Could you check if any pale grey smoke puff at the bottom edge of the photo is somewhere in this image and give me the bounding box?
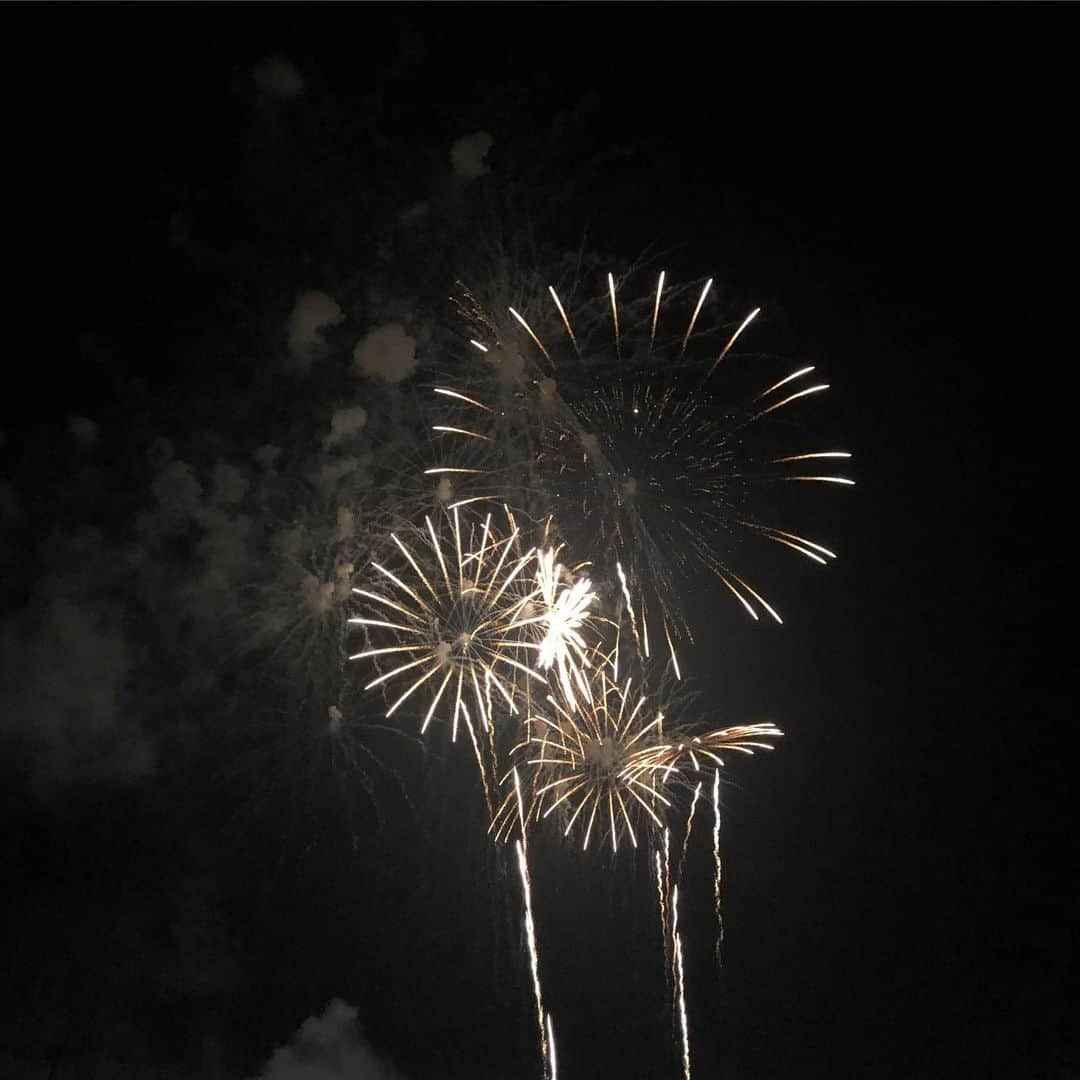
[255,998,402,1080]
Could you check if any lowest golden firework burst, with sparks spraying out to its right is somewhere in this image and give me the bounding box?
[491,630,782,852]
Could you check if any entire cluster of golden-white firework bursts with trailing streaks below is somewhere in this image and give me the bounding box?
[332,254,852,1080]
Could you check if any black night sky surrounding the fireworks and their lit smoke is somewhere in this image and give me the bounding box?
[0,4,1080,1080]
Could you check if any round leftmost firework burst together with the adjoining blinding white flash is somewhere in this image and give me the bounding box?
[350,508,592,738]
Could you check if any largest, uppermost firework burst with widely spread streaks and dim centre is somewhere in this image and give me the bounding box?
[429,267,852,667]
